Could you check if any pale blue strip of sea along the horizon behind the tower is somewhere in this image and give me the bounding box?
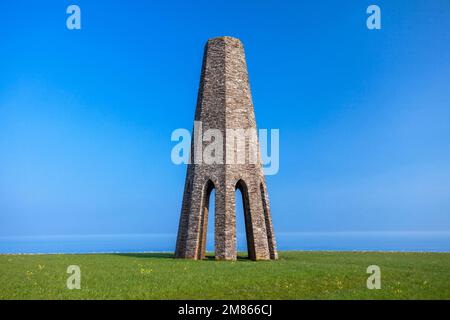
[0,232,450,253]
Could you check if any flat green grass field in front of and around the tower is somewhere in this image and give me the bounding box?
[0,251,450,299]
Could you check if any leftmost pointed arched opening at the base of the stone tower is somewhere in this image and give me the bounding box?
[197,180,215,259]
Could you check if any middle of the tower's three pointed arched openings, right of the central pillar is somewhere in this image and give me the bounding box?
[235,180,256,260]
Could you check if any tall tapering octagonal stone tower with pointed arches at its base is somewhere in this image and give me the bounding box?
[175,37,278,260]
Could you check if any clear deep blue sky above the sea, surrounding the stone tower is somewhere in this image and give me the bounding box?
[0,0,450,245]
